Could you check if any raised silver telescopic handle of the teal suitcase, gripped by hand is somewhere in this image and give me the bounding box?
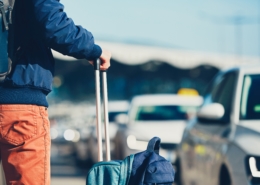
[94,59,111,161]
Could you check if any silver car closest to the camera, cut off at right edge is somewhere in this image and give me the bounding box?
[176,65,260,185]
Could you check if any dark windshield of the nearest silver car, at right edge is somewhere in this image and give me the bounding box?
[240,75,260,120]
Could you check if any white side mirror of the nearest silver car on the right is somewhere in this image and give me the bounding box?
[197,103,225,121]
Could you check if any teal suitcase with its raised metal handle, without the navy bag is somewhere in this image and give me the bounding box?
[86,59,133,185]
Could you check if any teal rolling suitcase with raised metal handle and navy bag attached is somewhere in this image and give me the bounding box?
[86,60,174,185]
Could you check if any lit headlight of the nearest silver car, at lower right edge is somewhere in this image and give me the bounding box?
[245,156,260,185]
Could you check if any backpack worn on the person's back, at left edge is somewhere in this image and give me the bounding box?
[0,0,15,82]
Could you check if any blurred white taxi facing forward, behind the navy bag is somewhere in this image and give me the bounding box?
[115,94,203,162]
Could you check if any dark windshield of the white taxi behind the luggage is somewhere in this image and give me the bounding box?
[135,105,196,121]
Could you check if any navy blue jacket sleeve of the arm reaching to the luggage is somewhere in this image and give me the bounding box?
[30,0,102,60]
